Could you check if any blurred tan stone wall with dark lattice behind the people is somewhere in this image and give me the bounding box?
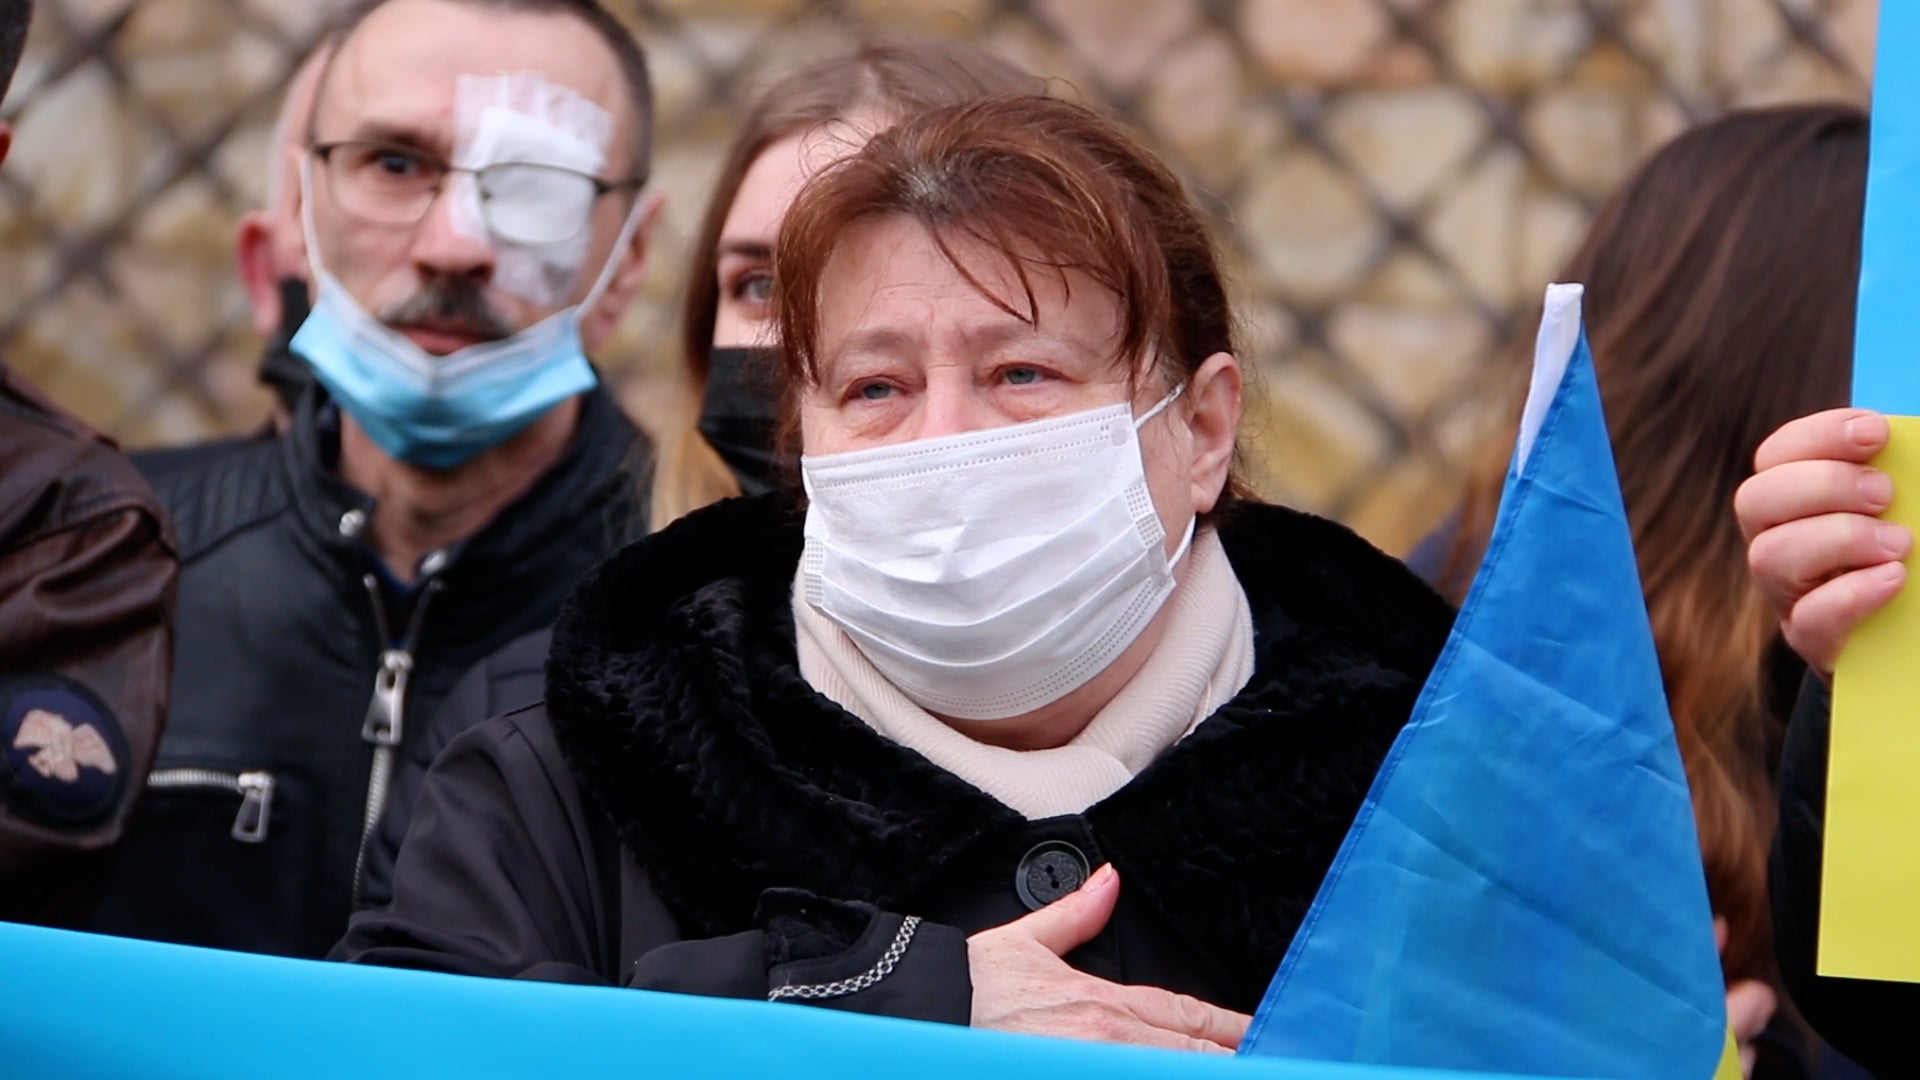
[0,0,1876,550]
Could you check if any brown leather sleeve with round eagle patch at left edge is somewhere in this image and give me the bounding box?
[0,367,179,926]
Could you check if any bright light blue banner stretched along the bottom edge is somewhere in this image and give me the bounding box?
[0,924,1543,1080]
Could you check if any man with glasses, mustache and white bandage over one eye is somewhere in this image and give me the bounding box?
[94,0,660,957]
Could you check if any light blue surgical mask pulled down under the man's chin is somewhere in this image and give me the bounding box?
[290,158,641,469]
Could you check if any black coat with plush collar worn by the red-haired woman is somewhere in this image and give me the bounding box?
[334,496,1452,1022]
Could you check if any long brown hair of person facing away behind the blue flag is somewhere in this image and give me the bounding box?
[1436,106,1866,1074]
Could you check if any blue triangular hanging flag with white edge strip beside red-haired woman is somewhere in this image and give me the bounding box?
[1240,284,1726,1080]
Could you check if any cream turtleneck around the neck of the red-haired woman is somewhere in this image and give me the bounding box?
[793,528,1254,821]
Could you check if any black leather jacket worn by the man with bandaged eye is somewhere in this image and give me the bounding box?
[94,388,645,957]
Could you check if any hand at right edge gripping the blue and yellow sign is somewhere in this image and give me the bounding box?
[1734,409,1912,678]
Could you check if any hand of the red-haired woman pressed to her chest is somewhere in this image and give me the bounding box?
[968,865,1252,1053]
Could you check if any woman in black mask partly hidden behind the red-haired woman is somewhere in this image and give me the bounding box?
[359,38,1044,907]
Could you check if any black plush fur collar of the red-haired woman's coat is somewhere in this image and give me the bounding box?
[547,496,1452,999]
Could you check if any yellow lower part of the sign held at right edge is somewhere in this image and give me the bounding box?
[1818,409,1920,982]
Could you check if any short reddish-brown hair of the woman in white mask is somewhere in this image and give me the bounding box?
[774,94,1244,509]
